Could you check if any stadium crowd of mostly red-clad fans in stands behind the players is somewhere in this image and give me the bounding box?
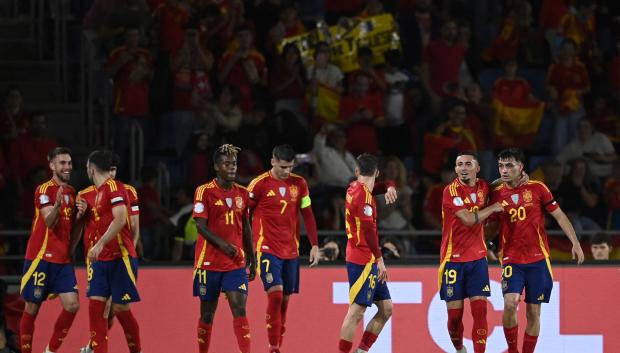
[0,0,620,271]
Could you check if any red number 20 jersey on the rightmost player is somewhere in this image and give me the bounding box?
[490,180,560,264]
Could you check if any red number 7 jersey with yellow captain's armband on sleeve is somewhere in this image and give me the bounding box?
[248,172,311,259]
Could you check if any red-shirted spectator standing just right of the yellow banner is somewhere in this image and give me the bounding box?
[422,19,466,105]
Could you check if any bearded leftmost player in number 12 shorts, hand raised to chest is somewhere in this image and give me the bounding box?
[20,147,84,353]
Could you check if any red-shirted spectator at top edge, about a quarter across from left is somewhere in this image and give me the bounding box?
[153,0,189,55]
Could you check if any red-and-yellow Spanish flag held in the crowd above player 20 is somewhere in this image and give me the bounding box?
[492,79,545,147]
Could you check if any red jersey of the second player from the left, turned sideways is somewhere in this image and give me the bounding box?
[93,179,137,261]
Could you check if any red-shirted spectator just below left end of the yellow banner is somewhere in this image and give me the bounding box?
[269,43,308,126]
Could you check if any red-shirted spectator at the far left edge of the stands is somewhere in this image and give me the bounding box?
[0,85,30,145]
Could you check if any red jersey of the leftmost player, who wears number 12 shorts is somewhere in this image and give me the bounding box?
[26,179,75,264]
